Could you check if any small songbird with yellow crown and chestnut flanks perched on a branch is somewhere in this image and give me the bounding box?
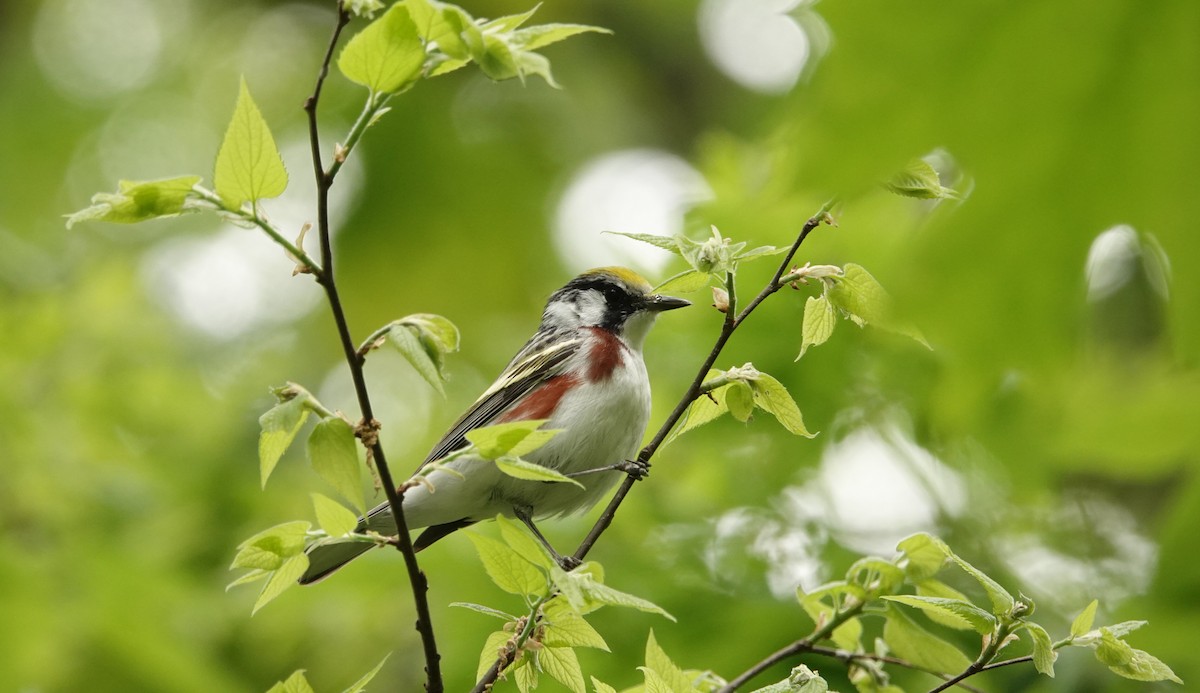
[300,267,690,584]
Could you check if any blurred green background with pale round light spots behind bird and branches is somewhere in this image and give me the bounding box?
[0,0,1200,691]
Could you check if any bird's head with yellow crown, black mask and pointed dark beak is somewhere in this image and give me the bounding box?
[542,267,691,348]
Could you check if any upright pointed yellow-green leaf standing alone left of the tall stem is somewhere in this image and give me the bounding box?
[212,78,288,210]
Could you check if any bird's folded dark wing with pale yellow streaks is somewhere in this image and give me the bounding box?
[418,332,583,469]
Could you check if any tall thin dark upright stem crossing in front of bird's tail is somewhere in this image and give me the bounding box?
[304,0,444,693]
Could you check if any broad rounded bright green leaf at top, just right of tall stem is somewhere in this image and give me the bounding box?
[337,2,425,94]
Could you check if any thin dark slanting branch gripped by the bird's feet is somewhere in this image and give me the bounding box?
[574,200,834,561]
